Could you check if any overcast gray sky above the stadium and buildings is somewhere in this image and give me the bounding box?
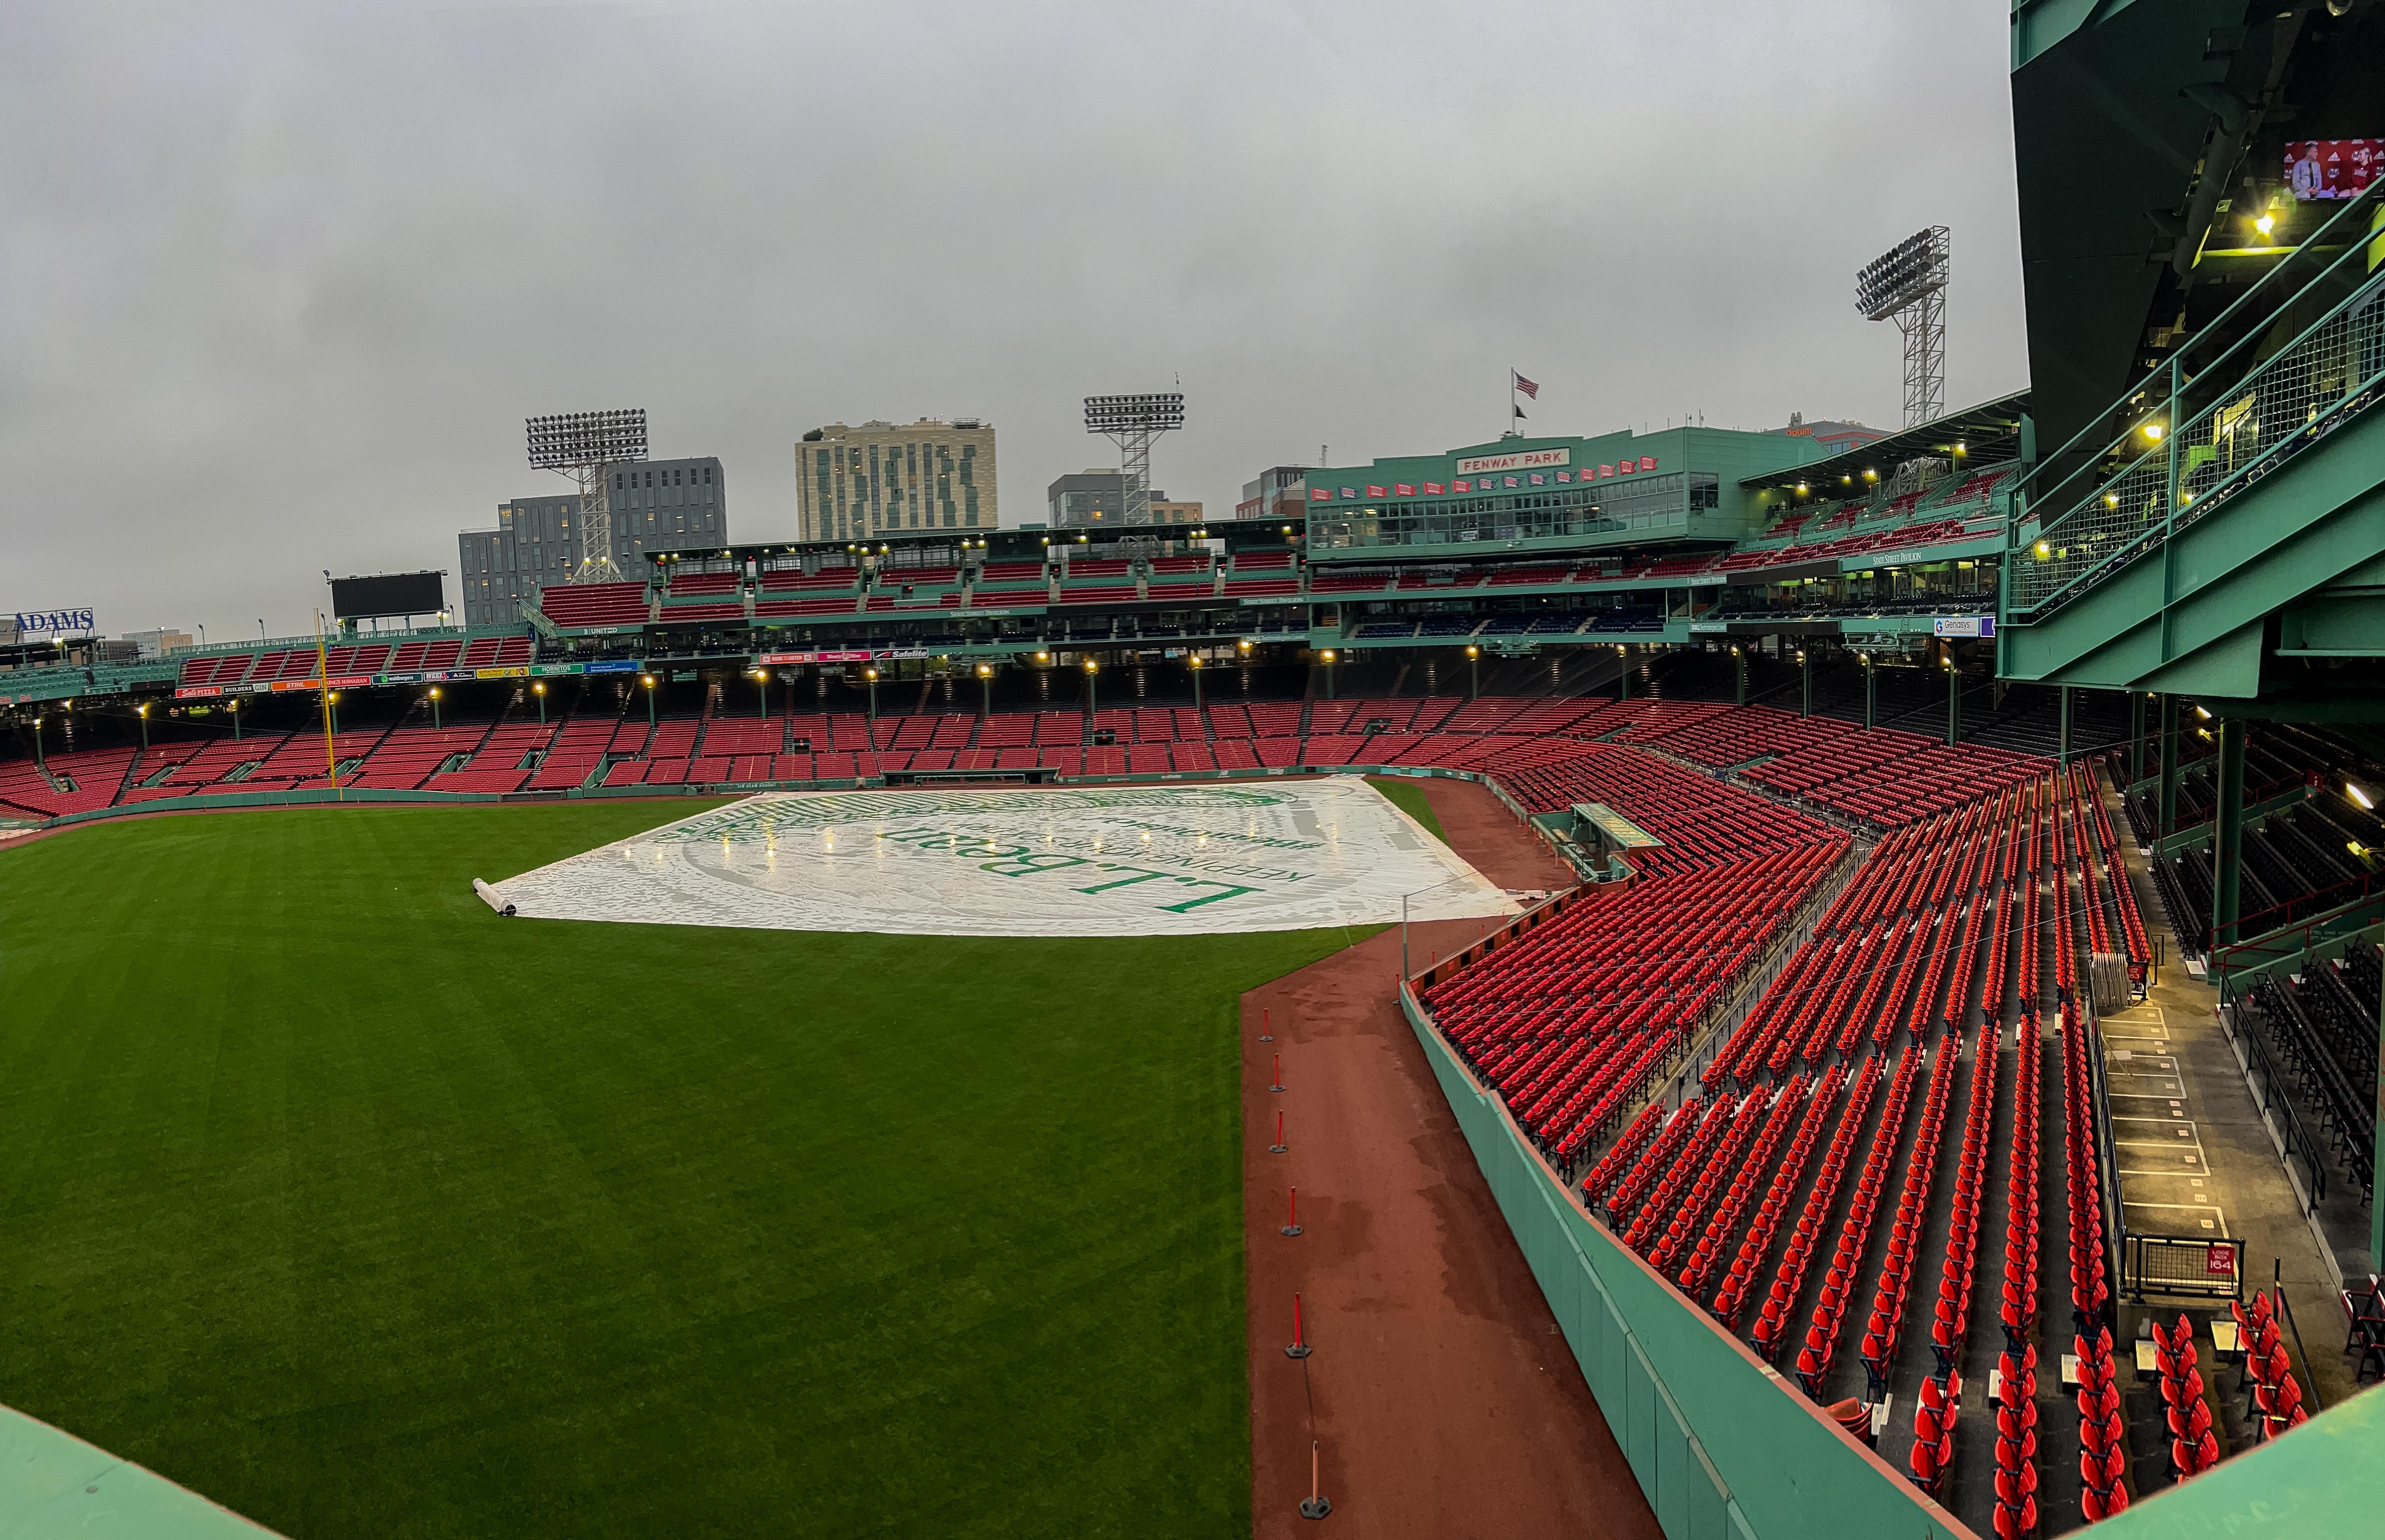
[0,0,2025,639]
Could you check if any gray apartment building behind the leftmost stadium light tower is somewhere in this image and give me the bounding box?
[456,455,730,625]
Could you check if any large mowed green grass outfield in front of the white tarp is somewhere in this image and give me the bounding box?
[0,801,1355,1540]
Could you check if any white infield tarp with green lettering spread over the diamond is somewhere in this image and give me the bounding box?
[491,780,1517,937]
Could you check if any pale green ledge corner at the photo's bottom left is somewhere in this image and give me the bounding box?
[0,1407,274,1540]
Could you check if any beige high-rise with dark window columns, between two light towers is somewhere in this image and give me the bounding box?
[794,417,1002,541]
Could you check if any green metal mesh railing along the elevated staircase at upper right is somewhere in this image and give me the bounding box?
[2006,193,2385,613]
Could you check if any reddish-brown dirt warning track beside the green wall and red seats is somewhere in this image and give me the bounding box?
[1243,780,1662,1540]
